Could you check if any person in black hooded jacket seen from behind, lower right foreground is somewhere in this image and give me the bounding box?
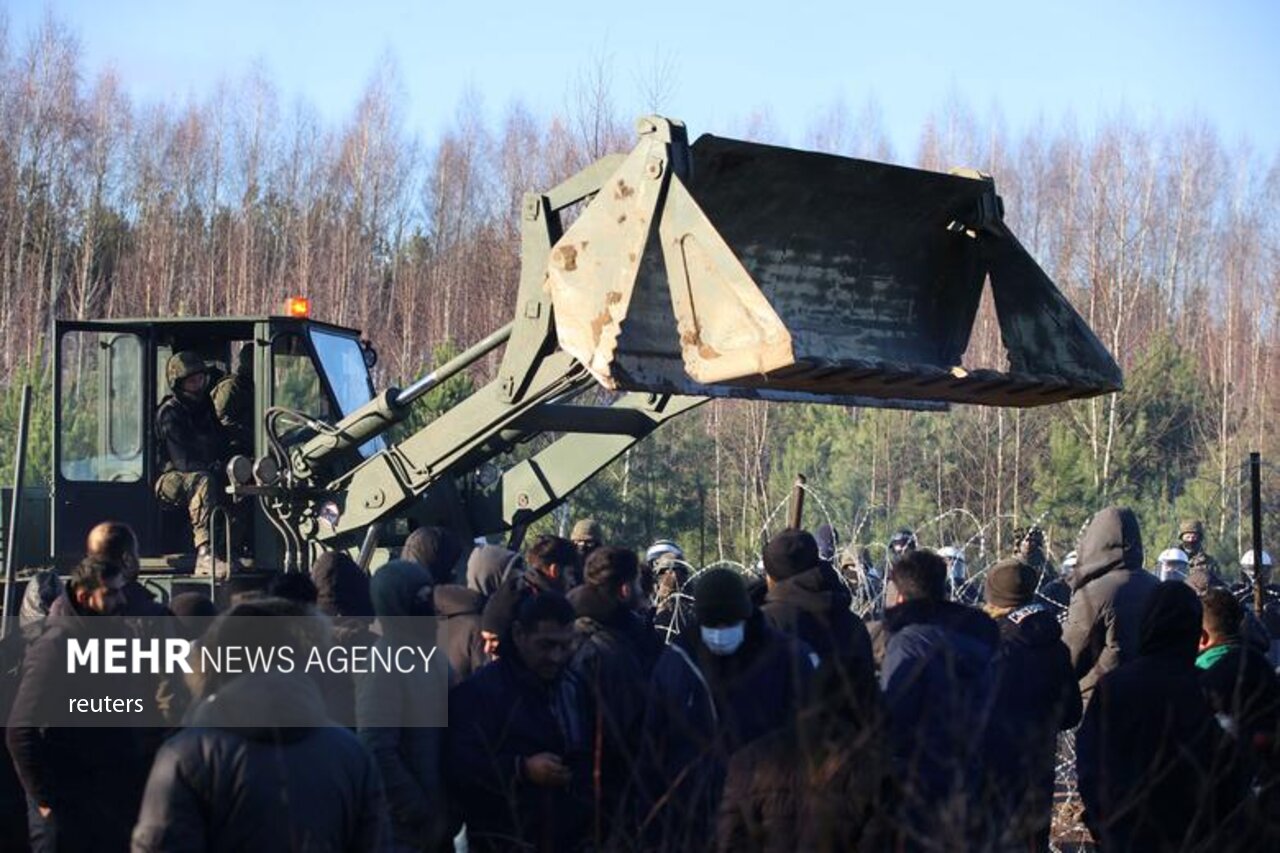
[1075,580,1245,852]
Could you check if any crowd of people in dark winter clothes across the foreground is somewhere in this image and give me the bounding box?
[0,507,1280,853]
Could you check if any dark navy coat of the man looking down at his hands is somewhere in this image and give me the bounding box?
[445,654,590,853]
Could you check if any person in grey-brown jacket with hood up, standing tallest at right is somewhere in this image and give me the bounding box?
[1062,506,1160,703]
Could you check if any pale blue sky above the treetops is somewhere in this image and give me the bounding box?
[0,0,1280,159]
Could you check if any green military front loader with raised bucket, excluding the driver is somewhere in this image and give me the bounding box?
[2,117,1121,601]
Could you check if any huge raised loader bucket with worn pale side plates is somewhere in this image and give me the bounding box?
[548,119,1123,407]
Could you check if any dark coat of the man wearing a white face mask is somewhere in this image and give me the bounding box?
[644,612,813,850]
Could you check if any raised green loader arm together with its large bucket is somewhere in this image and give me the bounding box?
[247,117,1121,563]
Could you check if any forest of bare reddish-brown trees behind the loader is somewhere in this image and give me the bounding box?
[0,18,1280,558]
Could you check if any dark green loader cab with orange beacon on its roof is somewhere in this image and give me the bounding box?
[47,307,381,570]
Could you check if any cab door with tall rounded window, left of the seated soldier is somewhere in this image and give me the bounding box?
[52,323,156,564]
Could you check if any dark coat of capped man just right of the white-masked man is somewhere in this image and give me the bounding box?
[760,566,876,681]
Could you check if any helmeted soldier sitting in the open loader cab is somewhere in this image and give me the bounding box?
[156,352,227,551]
